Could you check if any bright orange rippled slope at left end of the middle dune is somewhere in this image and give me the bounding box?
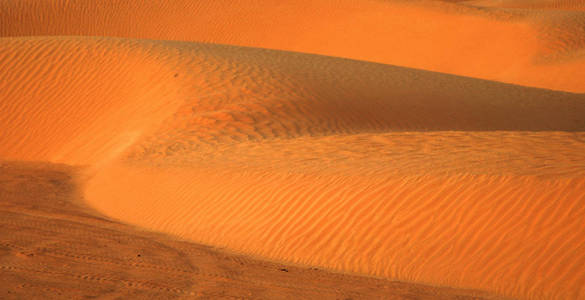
[0,38,184,165]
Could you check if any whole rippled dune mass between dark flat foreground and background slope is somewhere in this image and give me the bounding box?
[0,37,585,298]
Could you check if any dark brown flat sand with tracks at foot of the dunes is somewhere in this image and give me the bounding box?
[0,161,498,299]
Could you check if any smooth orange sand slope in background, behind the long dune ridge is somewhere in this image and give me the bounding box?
[0,0,585,93]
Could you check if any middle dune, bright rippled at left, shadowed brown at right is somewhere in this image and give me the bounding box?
[0,38,585,164]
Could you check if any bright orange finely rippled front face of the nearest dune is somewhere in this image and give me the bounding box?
[86,166,585,299]
